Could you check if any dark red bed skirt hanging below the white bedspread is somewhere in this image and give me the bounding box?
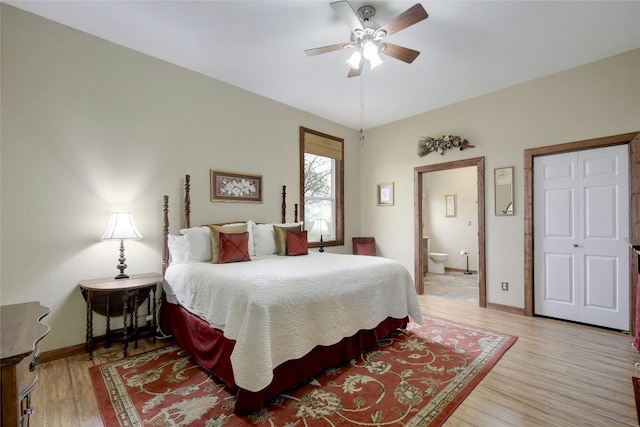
[160,296,409,415]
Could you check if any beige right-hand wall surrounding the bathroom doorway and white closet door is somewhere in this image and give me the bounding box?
[361,50,640,307]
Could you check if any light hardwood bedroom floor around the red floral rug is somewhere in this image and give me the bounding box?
[32,295,640,427]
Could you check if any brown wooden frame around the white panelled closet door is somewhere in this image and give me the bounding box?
[524,132,640,322]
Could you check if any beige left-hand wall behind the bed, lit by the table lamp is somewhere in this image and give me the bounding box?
[0,4,360,350]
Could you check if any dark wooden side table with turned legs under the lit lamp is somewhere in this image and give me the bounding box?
[78,273,162,359]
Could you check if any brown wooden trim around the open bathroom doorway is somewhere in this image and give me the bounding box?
[413,157,487,307]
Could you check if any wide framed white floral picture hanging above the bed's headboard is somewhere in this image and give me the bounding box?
[210,169,262,203]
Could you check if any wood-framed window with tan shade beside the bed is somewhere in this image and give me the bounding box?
[300,127,344,247]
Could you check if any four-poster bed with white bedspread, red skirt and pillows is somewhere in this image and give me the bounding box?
[160,176,422,415]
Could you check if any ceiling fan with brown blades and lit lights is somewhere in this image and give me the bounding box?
[304,0,429,77]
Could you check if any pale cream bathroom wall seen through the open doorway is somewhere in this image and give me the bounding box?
[422,166,478,271]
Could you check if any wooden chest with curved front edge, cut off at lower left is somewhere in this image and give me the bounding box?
[0,302,49,427]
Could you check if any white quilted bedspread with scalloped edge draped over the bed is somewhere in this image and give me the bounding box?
[164,252,422,391]
